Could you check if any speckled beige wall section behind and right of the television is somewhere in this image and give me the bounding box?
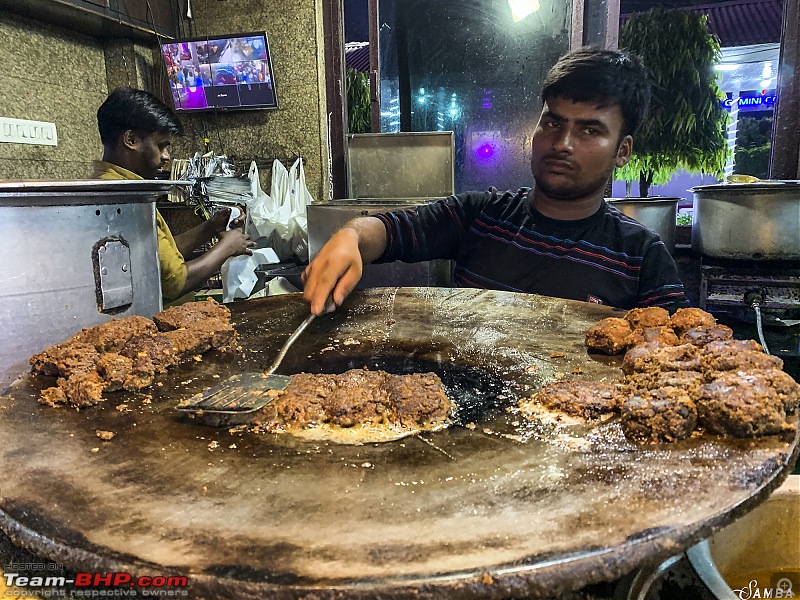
[173,0,328,200]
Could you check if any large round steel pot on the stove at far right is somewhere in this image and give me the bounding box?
[692,181,800,260]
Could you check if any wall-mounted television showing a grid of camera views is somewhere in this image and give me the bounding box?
[161,32,278,112]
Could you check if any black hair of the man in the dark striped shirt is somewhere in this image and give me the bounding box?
[542,46,652,139]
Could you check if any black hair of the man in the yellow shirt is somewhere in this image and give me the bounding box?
[97,88,183,144]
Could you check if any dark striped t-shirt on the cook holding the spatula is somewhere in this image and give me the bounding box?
[375,188,689,310]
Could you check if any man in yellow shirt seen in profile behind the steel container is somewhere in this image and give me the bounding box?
[92,88,255,304]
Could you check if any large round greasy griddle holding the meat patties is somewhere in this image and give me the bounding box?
[0,288,798,599]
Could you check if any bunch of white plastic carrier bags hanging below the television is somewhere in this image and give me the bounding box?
[247,158,314,262]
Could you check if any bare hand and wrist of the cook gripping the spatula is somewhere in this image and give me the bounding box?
[303,217,386,315]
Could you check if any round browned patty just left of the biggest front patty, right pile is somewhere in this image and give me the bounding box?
[622,386,697,442]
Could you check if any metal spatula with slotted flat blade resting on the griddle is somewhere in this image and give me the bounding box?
[177,313,316,425]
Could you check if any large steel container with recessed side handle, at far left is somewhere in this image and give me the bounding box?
[0,180,176,390]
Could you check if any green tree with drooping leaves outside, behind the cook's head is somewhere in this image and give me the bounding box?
[617,9,728,197]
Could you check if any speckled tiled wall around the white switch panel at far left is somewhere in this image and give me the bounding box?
[0,12,107,179]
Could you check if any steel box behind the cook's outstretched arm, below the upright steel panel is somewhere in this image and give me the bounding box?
[306,198,452,289]
